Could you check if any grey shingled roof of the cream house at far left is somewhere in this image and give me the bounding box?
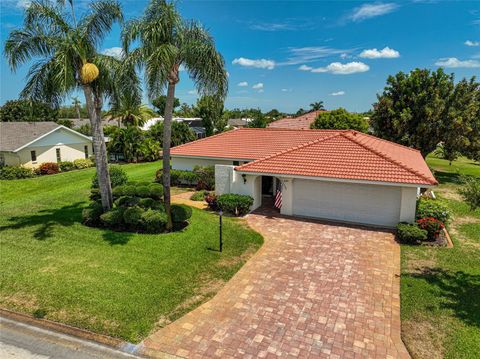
[0,122,91,152]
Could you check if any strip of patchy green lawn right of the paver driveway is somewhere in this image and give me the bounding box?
[401,156,480,359]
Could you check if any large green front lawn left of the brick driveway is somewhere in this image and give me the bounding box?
[0,162,262,342]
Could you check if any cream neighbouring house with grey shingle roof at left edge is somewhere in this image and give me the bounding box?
[0,122,93,168]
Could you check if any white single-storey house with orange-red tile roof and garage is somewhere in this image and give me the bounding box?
[171,128,437,227]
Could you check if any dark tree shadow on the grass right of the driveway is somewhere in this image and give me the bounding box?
[409,268,480,327]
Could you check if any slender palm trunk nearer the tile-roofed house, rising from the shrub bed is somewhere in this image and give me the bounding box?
[162,82,175,230]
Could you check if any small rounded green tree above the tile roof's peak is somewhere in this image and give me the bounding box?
[311,108,368,133]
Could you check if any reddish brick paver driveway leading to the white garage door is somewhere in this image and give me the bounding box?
[143,211,409,358]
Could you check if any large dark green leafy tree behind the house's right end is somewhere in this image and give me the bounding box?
[372,68,480,159]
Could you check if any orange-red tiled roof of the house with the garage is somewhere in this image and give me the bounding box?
[172,128,437,185]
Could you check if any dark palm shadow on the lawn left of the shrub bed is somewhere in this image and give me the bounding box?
[0,202,84,241]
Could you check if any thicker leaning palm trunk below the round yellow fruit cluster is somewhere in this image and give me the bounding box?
[83,85,113,211]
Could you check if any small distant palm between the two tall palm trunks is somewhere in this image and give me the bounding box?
[107,92,155,127]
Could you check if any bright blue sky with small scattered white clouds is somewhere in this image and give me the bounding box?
[0,0,480,112]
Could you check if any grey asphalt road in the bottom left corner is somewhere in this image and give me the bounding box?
[0,317,142,359]
